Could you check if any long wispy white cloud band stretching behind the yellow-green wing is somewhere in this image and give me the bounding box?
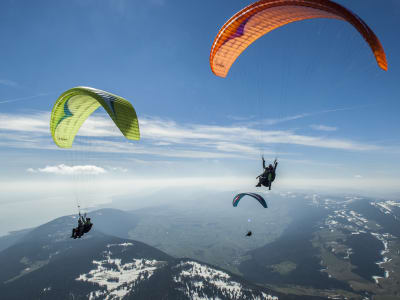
[0,113,382,159]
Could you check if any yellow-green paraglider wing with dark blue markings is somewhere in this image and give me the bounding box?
[50,87,140,148]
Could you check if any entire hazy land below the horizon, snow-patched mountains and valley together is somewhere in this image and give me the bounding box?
[0,193,400,300]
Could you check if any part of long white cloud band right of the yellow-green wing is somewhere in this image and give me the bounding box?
[141,118,379,153]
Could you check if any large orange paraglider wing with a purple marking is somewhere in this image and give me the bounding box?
[210,0,387,77]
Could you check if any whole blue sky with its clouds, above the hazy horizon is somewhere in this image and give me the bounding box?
[0,0,400,234]
